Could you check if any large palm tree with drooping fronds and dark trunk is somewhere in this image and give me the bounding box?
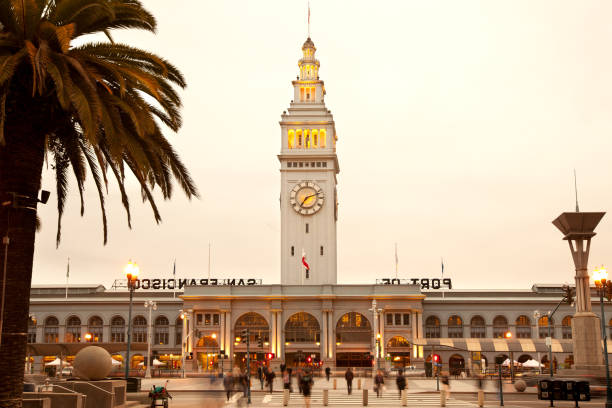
[0,0,197,407]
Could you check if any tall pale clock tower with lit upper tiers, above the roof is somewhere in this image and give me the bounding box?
[278,37,340,285]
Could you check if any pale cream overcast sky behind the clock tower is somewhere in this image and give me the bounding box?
[33,0,612,289]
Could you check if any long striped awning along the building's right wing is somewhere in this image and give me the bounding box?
[414,338,576,354]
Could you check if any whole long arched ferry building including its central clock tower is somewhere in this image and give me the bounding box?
[22,38,612,372]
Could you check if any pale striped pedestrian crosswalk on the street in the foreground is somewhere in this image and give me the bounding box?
[263,390,476,408]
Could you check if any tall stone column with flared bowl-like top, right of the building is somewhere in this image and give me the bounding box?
[551,212,605,374]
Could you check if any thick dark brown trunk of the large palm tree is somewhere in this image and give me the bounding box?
[0,120,45,408]
